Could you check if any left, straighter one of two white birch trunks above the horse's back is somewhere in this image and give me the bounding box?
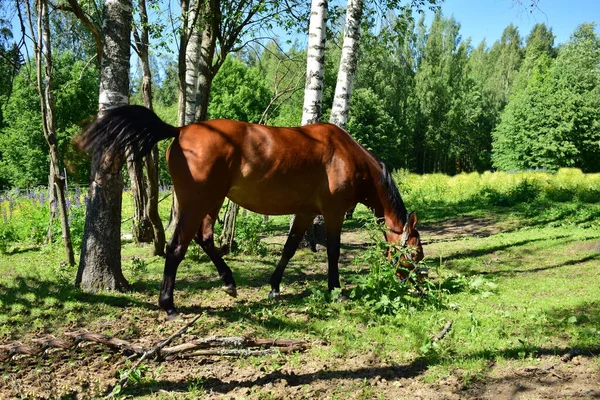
[302,0,327,125]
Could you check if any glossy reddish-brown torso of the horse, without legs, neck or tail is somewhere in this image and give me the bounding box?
[169,120,376,214]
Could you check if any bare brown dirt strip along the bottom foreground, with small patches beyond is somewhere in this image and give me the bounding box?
[0,218,600,399]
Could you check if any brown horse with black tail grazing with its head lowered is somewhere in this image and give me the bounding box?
[80,106,423,317]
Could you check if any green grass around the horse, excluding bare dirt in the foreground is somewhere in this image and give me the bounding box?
[0,168,600,398]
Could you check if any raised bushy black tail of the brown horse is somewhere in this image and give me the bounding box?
[79,106,179,160]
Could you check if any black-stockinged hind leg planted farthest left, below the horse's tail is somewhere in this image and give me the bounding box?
[158,212,201,319]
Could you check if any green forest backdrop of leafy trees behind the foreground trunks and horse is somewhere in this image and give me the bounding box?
[0,3,600,189]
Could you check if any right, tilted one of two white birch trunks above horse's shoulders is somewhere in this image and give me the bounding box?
[329,0,363,129]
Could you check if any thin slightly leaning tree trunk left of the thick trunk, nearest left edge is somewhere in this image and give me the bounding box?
[36,0,75,265]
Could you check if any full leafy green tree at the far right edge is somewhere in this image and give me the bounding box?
[493,24,600,172]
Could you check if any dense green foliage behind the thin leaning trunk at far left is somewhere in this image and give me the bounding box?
[0,51,98,188]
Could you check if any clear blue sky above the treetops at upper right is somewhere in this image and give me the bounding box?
[426,0,600,46]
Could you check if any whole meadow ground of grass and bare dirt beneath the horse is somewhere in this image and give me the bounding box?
[0,169,600,399]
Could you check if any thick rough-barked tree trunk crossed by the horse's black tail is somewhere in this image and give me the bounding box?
[75,0,132,291]
